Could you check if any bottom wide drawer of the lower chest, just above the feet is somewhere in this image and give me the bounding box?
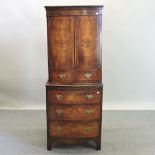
[49,121,99,138]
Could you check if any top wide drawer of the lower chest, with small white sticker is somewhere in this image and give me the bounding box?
[48,90,101,104]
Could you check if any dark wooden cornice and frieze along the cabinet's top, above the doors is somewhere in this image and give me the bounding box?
[45,5,103,16]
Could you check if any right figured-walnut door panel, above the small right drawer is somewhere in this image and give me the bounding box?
[76,16,100,69]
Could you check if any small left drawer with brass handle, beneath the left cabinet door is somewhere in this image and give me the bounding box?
[50,71,75,84]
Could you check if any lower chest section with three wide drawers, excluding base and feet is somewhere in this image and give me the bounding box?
[46,86,102,138]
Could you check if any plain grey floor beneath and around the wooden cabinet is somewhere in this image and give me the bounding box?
[0,110,155,155]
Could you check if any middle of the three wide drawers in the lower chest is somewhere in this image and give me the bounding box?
[48,104,100,121]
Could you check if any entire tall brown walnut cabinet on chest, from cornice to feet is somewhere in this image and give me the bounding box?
[45,6,103,150]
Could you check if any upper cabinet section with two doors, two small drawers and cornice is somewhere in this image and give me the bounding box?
[46,6,102,84]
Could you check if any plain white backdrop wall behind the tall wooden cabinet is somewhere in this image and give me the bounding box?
[0,0,155,109]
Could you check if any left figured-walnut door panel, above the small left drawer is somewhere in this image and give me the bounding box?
[48,16,74,70]
